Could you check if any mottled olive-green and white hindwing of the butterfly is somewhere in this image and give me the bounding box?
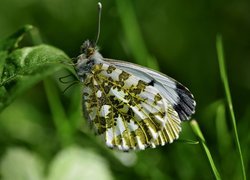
[83,63,181,151]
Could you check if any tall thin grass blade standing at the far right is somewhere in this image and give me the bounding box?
[216,35,246,180]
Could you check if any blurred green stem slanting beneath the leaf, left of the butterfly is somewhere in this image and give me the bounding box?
[44,78,73,146]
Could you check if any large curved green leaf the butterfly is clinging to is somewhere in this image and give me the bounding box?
[0,45,74,111]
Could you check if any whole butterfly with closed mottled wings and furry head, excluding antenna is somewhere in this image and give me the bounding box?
[75,41,195,151]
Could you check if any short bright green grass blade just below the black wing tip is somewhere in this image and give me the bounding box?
[190,120,221,180]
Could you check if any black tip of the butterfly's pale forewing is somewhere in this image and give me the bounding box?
[174,83,196,121]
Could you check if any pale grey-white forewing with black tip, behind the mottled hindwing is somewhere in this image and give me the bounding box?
[104,58,196,120]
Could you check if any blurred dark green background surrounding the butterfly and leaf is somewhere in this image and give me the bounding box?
[0,0,250,180]
